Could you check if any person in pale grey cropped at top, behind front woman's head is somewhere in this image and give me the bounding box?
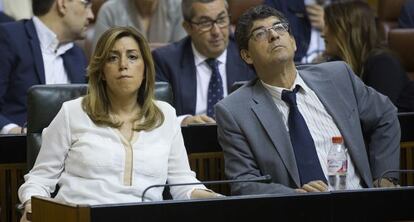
[93,0,185,49]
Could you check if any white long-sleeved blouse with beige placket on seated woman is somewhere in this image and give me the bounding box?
[19,98,206,205]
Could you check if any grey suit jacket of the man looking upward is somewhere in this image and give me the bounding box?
[215,62,401,194]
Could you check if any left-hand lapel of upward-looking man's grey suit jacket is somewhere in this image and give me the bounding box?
[252,80,300,187]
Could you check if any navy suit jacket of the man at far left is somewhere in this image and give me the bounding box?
[0,20,87,129]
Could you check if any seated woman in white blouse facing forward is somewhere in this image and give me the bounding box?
[19,27,222,222]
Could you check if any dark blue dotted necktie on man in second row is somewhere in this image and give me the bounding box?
[206,59,223,118]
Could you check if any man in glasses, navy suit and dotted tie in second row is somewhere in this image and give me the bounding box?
[153,0,255,125]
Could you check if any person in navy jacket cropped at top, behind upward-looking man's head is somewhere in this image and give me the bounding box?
[264,0,331,63]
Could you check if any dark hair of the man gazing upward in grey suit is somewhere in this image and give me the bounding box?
[235,5,291,50]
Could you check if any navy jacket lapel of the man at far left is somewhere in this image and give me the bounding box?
[25,20,46,84]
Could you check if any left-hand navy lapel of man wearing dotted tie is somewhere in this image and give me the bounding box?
[178,38,197,114]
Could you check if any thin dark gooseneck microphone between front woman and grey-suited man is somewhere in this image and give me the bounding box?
[141,175,272,202]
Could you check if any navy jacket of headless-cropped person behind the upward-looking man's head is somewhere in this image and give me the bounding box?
[265,0,311,62]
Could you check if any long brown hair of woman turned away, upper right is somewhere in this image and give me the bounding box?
[325,1,382,78]
